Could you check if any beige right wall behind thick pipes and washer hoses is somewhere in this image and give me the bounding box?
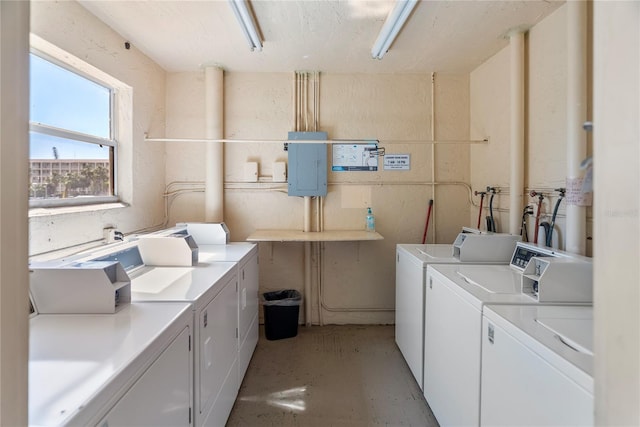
[470,5,592,251]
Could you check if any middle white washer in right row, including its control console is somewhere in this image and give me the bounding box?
[423,242,593,426]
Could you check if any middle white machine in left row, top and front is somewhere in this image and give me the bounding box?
[129,261,240,426]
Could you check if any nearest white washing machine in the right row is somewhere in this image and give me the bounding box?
[480,305,594,426]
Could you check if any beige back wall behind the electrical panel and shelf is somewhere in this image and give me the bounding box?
[166,72,469,323]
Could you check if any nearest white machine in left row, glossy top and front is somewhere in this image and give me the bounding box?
[28,303,193,427]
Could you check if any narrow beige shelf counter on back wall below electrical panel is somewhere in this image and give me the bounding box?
[247,230,384,242]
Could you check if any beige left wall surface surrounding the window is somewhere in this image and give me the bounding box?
[29,1,165,254]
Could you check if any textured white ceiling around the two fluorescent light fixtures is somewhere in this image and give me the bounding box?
[79,0,564,73]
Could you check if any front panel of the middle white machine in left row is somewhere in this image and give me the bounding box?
[196,275,239,425]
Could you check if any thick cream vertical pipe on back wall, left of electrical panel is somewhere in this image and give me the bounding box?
[204,67,224,222]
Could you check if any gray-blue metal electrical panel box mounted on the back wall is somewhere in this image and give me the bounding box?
[288,132,327,196]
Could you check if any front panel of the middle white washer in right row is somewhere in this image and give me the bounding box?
[424,272,482,426]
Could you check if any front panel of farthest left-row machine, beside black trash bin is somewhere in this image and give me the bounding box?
[238,247,259,383]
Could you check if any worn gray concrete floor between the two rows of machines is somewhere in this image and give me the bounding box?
[227,325,438,427]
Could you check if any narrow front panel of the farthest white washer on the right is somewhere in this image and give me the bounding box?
[395,247,424,389]
